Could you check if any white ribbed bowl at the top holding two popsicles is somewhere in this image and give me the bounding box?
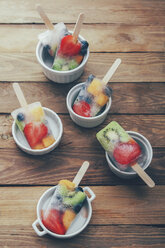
[36,31,89,83]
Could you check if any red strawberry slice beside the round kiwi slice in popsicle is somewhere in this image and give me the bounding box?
[113,142,141,165]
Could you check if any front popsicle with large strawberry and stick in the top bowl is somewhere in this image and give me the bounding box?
[52,13,88,71]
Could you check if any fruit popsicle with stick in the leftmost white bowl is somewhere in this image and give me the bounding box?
[11,83,55,149]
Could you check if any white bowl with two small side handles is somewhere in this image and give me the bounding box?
[32,186,96,239]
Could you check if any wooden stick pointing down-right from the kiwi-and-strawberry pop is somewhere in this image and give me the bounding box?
[131,164,155,188]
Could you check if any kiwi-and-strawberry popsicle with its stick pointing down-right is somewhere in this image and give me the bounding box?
[96,121,155,187]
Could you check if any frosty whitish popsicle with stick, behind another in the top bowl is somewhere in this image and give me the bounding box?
[36,5,68,57]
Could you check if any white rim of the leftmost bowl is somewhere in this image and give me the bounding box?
[12,107,63,155]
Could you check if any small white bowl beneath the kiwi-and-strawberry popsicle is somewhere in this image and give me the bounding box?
[105,131,153,179]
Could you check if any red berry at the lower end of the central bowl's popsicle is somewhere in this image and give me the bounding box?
[73,101,91,117]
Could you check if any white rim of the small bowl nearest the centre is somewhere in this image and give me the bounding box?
[66,82,112,120]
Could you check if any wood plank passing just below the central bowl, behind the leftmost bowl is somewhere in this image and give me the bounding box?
[0,114,165,147]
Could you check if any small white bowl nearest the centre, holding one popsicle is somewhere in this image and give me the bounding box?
[66,83,112,128]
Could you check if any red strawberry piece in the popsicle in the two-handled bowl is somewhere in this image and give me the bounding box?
[42,209,66,235]
